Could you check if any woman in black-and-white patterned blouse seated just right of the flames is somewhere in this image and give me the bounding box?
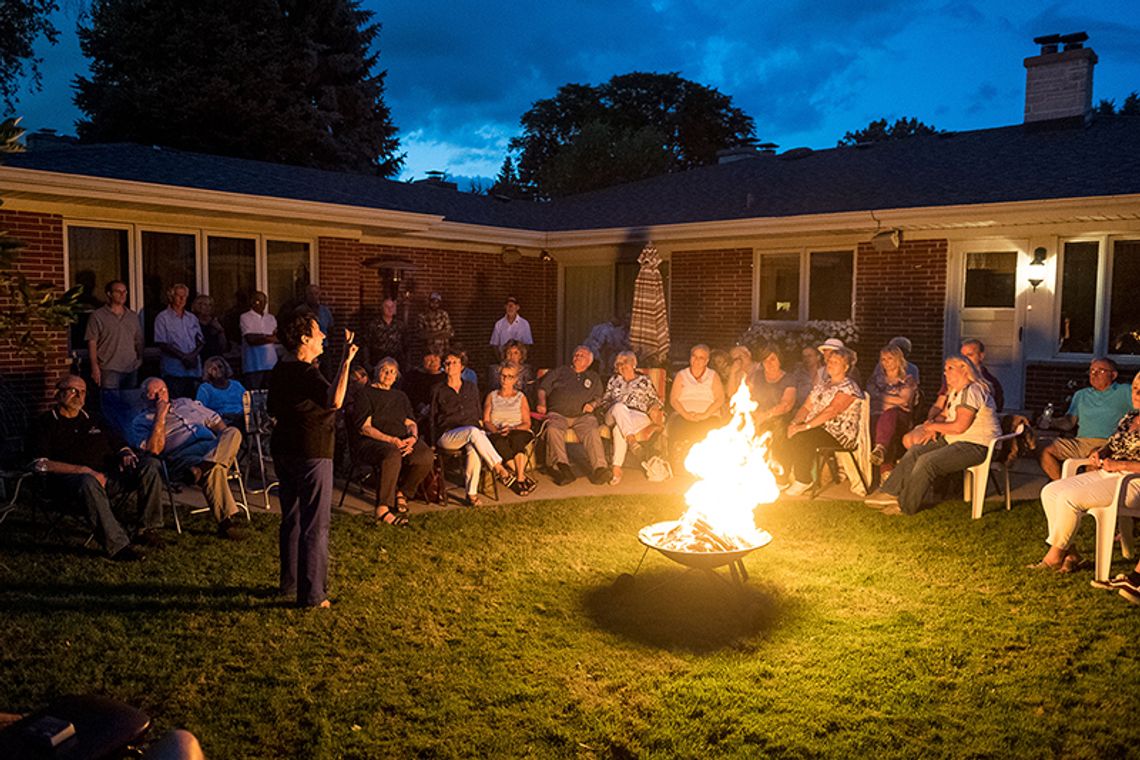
[777,348,863,496]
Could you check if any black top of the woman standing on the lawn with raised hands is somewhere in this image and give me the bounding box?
[266,357,336,459]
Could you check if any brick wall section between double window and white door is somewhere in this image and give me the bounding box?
[855,240,948,401]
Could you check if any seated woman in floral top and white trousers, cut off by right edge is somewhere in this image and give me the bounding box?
[1034,375,1140,578]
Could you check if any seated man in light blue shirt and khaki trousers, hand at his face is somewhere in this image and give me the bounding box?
[130,377,245,540]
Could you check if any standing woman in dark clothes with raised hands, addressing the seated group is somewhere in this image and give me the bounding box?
[266,313,358,607]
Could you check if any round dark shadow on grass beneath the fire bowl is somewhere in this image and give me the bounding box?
[583,567,797,653]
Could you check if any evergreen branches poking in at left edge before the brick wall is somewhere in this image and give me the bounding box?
[0,119,82,356]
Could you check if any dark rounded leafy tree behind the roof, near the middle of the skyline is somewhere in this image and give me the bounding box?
[511,72,756,196]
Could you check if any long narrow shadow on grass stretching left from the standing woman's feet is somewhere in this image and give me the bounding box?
[0,581,284,615]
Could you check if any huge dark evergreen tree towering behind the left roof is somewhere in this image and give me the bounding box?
[75,0,404,177]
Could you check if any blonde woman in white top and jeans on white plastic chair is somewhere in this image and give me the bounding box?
[868,353,1001,515]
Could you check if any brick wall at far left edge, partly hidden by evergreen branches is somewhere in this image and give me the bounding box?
[0,209,71,421]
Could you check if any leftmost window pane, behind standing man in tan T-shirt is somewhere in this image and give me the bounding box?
[67,227,130,351]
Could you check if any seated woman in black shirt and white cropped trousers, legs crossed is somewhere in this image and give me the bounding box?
[431,351,514,507]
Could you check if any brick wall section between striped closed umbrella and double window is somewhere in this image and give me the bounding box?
[669,248,752,360]
